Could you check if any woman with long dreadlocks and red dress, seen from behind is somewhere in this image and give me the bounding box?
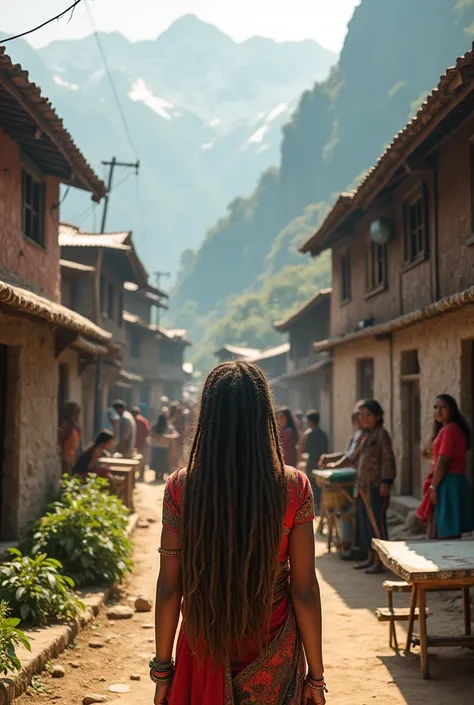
[150,361,326,705]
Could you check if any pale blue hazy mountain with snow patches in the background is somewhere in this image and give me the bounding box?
[3,15,337,271]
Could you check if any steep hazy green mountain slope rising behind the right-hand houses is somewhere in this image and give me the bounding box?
[173,0,474,367]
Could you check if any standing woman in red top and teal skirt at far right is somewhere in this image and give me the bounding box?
[417,394,474,539]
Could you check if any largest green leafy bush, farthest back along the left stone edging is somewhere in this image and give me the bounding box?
[30,476,132,586]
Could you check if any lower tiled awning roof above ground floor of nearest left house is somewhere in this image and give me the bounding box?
[0,281,112,343]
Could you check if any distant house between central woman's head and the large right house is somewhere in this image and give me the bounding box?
[274,289,332,437]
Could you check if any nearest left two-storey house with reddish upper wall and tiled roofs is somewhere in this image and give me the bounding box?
[0,47,106,541]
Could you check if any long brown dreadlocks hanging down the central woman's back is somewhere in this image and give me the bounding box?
[182,361,287,664]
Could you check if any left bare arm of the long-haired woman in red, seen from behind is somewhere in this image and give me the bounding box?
[155,528,183,663]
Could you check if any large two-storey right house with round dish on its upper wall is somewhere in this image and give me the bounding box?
[302,44,474,507]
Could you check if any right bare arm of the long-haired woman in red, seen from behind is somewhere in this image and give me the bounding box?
[289,522,324,679]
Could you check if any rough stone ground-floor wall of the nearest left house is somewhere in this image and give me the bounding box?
[0,313,60,540]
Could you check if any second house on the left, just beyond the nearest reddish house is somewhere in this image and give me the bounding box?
[59,223,148,440]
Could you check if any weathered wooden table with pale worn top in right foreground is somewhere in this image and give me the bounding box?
[372,539,474,678]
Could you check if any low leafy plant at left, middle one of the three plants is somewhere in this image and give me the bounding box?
[0,548,84,624]
